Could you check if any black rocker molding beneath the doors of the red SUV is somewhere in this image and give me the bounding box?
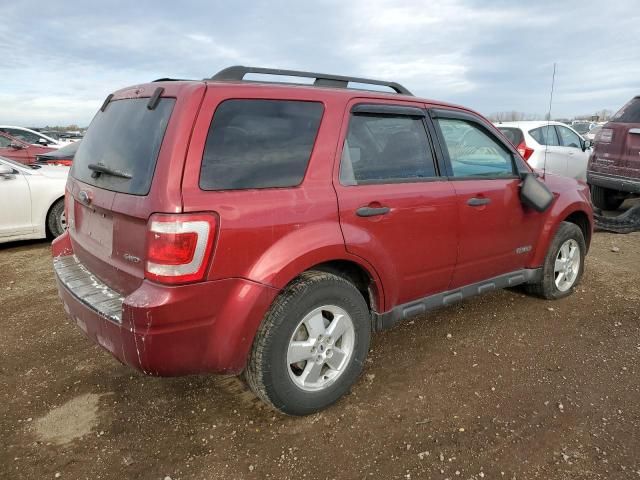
[372,268,542,331]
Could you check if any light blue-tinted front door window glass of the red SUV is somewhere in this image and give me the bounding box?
[437,118,514,177]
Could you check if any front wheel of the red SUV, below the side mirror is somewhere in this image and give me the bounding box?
[527,222,587,300]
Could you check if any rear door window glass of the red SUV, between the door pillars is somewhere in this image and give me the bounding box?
[340,114,436,185]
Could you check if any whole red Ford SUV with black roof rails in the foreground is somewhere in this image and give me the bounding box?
[53,67,593,415]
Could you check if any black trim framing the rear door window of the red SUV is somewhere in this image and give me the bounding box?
[337,102,446,188]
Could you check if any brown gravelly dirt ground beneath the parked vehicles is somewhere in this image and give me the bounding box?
[0,233,640,480]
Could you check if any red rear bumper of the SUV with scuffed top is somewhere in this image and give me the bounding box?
[53,234,278,376]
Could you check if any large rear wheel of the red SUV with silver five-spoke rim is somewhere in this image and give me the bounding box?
[244,271,371,415]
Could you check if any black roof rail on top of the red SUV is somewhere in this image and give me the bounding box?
[211,65,413,95]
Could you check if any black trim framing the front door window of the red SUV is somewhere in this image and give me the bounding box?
[428,108,530,181]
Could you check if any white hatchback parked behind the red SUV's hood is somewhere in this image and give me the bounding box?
[496,121,591,181]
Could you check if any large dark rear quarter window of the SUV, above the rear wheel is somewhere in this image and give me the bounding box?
[200,100,323,190]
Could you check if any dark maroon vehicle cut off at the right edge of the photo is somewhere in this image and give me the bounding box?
[587,95,640,210]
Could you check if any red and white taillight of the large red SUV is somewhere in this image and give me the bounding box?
[144,213,217,284]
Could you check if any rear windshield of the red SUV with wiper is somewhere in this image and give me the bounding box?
[71,98,175,195]
